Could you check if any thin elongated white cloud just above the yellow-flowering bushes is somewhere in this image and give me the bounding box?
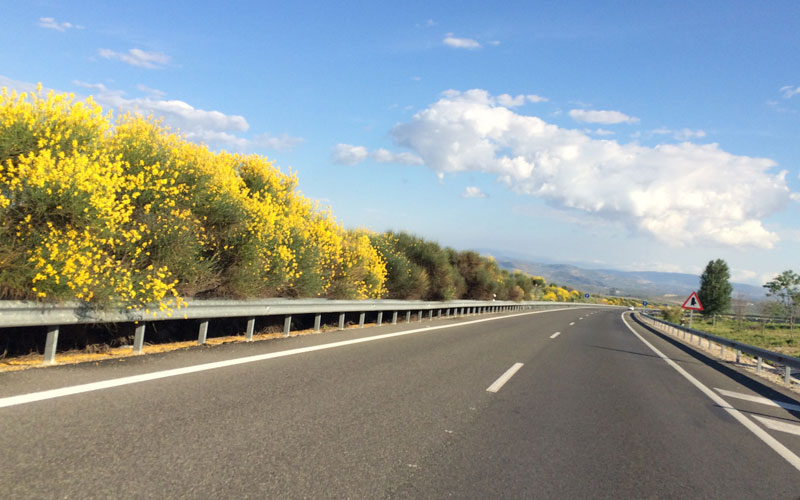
[72,80,303,152]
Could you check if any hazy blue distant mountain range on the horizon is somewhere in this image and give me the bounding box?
[482,251,766,304]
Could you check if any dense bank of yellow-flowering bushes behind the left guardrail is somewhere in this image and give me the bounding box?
[0,89,600,310]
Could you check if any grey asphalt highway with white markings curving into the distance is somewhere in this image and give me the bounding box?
[0,308,800,499]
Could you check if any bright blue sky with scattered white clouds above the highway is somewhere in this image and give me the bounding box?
[0,1,800,285]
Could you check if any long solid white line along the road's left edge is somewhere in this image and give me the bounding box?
[0,307,568,408]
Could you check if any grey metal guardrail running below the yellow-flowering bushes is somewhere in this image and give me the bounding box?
[0,299,615,364]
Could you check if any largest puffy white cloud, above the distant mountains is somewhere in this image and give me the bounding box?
[392,89,791,248]
